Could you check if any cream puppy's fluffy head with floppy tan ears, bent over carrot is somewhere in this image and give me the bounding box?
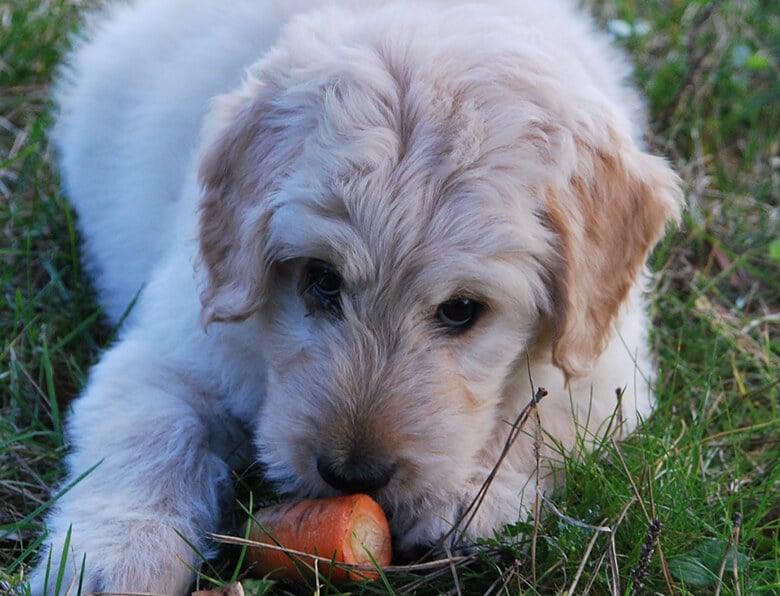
[201,5,679,548]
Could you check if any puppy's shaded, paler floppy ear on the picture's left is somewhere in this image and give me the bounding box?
[199,80,299,325]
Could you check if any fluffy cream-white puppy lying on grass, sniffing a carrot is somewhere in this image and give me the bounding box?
[33,0,682,594]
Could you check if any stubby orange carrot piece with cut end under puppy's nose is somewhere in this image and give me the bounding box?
[247,495,392,583]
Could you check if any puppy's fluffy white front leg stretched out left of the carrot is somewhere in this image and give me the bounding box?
[32,339,238,594]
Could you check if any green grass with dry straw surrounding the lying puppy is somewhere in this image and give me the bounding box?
[0,0,780,595]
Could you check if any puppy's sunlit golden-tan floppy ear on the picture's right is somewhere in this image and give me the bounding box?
[547,135,683,380]
